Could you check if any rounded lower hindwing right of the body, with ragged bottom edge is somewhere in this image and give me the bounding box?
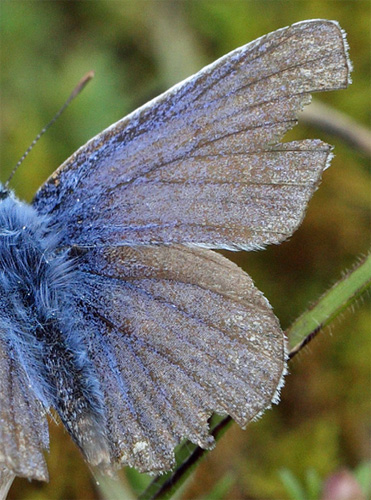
[76,245,285,472]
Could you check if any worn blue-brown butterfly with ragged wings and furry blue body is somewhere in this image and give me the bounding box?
[0,20,351,480]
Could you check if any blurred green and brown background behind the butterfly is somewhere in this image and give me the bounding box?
[0,0,371,500]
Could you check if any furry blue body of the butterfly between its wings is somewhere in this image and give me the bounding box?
[0,190,109,464]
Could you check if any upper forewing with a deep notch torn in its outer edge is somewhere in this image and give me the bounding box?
[34,20,350,249]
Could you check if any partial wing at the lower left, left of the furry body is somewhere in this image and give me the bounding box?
[0,341,49,478]
